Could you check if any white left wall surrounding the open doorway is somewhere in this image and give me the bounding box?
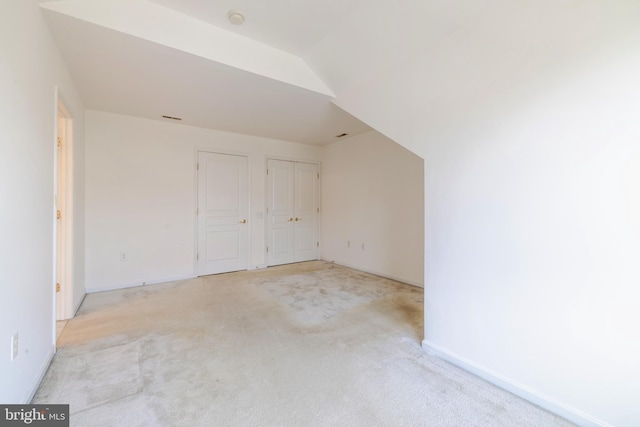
[0,0,84,403]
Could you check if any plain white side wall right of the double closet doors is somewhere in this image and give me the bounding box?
[322,131,424,286]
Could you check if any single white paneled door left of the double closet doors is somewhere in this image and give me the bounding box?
[198,152,249,276]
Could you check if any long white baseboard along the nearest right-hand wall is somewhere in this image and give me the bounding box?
[422,340,613,427]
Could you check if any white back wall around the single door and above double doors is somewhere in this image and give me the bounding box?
[86,110,321,292]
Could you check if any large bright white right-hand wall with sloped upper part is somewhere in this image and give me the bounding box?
[307,0,640,426]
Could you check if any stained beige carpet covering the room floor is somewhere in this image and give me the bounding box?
[34,262,571,427]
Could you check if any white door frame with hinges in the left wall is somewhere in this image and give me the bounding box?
[52,87,74,324]
